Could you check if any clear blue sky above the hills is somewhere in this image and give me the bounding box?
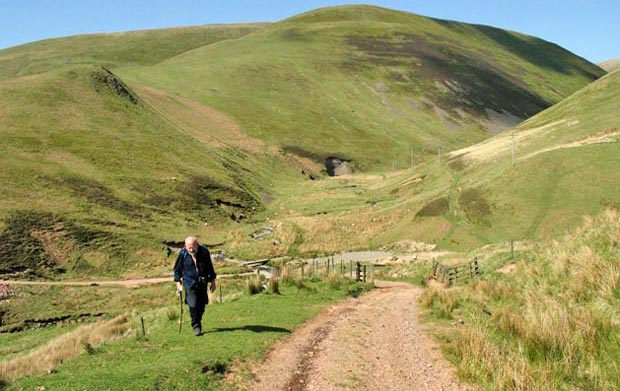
[0,0,620,62]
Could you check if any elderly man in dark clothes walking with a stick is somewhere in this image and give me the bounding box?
[174,236,217,336]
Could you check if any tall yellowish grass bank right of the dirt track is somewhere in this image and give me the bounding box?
[421,210,620,390]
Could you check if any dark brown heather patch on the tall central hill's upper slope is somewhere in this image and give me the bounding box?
[345,33,551,118]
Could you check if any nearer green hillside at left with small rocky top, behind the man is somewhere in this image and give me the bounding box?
[0,66,290,275]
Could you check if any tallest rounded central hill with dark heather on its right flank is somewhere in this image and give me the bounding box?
[117,6,604,170]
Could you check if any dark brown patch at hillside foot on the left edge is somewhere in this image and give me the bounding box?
[0,211,113,276]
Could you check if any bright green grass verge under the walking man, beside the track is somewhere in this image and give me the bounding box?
[5,280,366,390]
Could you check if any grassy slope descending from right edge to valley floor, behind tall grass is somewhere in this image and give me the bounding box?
[234,66,620,253]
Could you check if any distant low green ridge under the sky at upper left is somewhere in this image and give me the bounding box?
[0,23,264,80]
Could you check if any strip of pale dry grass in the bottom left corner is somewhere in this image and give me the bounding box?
[0,315,129,381]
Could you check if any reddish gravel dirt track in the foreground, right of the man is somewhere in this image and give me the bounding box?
[244,282,467,391]
